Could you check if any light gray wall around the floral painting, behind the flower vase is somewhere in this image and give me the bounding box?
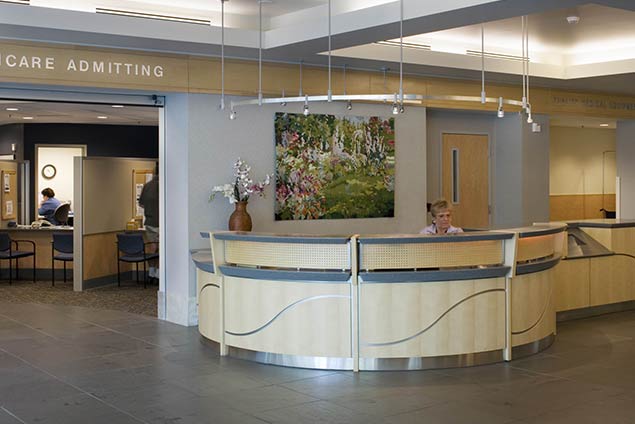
[189,94,426,248]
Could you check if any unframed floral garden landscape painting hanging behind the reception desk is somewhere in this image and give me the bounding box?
[275,113,395,220]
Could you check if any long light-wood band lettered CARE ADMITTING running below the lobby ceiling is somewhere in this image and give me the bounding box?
[0,41,635,118]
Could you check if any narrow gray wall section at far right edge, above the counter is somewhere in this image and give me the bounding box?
[615,121,635,219]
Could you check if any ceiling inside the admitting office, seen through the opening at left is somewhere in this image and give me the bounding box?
[0,100,159,126]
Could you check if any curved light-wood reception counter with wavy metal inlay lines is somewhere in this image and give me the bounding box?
[193,224,566,371]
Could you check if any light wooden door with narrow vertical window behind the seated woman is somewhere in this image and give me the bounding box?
[441,134,489,228]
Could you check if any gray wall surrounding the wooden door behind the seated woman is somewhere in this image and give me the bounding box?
[427,109,549,228]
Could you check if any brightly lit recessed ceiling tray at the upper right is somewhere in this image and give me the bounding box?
[335,2,635,80]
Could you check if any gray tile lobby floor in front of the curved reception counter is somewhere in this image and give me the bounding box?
[0,303,635,424]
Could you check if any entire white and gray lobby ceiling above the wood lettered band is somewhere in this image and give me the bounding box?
[0,0,635,95]
